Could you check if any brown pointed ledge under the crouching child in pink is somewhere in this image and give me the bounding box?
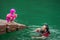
[0,19,26,34]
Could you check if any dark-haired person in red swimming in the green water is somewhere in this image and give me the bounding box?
[32,24,50,39]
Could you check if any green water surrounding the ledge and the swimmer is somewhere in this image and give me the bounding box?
[0,0,60,40]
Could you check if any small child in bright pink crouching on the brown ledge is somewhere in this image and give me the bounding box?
[6,9,17,23]
